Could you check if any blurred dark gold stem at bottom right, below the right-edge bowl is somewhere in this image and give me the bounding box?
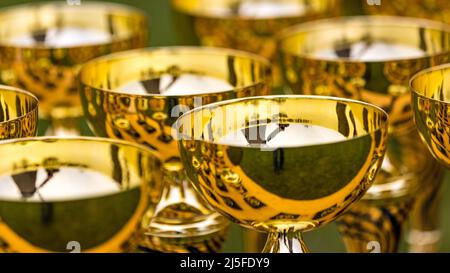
[407,162,444,253]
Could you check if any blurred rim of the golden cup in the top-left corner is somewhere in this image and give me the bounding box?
[0,1,148,51]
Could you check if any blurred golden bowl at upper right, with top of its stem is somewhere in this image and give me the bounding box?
[280,16,450,123]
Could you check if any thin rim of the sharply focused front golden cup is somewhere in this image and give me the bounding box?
[174,95,389,149]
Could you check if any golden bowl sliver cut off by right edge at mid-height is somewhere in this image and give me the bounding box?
[411,64,450,168]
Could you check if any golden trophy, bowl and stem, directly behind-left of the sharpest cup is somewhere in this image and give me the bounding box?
[79,47,270,252]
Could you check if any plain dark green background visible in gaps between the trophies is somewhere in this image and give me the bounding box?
[0,0,450,252]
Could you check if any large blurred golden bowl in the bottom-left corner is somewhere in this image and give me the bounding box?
[0,137,162,252]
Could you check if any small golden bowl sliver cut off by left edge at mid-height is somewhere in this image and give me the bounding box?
[0,85,39,140]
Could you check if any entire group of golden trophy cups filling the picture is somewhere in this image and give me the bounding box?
[0,0,450,252]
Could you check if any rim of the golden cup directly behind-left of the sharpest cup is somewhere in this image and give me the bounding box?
[78,46,272,99]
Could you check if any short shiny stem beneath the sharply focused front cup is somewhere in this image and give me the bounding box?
[262,229,309,253]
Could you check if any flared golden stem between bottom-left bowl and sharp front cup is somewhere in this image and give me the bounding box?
[141,159,229,253]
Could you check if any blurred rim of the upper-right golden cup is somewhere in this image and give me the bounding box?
[277,15,450,64]
